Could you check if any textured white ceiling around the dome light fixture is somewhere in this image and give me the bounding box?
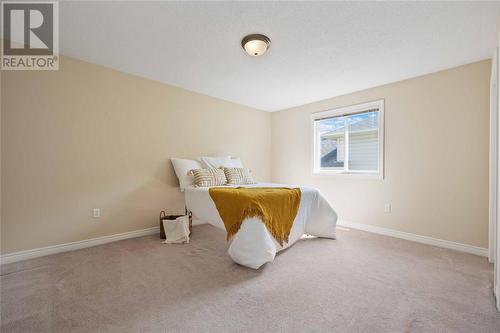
[60,2,498,111]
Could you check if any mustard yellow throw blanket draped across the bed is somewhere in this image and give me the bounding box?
[208,187,301,246]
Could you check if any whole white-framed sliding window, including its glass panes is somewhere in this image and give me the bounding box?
[312,100,384,178]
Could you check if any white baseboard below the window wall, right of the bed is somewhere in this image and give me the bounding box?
[337,220,488,257]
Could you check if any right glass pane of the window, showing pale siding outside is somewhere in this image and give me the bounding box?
[347,111,379,171]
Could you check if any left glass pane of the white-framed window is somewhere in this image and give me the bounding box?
[318,117,345,169]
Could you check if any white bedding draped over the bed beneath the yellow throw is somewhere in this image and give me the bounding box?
[185,183,337,269]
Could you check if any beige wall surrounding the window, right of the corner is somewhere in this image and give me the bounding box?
[271,60,491,247]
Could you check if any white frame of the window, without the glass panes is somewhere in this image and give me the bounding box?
[311,99,384,179]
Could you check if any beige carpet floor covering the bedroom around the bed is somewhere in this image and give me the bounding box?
[1,225,500,333]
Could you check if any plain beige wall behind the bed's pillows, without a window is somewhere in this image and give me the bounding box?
[1,57,271,254]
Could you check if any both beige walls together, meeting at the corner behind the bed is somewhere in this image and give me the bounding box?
[0,57,490,254]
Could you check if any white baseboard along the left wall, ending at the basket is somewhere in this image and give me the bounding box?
[0,227,160,265]
